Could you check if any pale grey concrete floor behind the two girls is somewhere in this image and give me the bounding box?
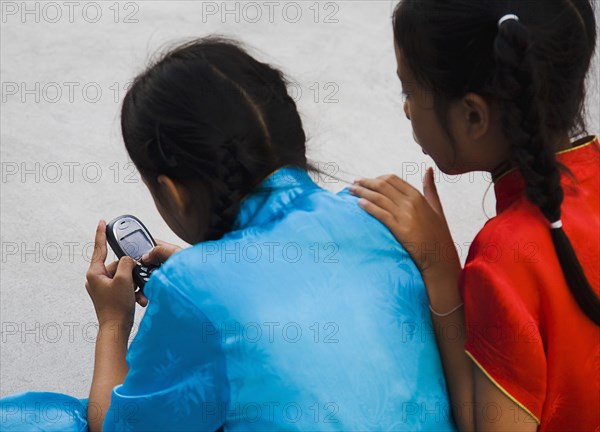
[0,0,600,397]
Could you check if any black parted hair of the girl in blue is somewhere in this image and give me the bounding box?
[121,37,311,240]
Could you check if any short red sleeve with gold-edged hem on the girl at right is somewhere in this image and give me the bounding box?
[460,203,555,423]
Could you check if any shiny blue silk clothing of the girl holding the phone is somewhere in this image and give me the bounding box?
[0,167,455,431]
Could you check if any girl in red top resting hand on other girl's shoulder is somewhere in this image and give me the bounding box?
[351,0,600,431]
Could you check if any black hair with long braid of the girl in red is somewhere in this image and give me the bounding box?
[394,0,600,325]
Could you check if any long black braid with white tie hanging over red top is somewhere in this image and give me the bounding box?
[494,16,600,325]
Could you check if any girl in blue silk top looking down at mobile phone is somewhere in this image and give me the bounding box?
[1,38,454,431]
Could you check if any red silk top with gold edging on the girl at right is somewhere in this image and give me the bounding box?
[460,137,600,432]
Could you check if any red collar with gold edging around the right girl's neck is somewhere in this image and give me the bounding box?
[494,136,600,214]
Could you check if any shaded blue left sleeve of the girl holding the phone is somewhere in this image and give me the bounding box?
[102,268,229,431]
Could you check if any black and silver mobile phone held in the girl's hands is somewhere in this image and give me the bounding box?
[106,215,159,291]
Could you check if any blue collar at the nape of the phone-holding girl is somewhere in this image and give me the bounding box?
[231,165,320,231]
